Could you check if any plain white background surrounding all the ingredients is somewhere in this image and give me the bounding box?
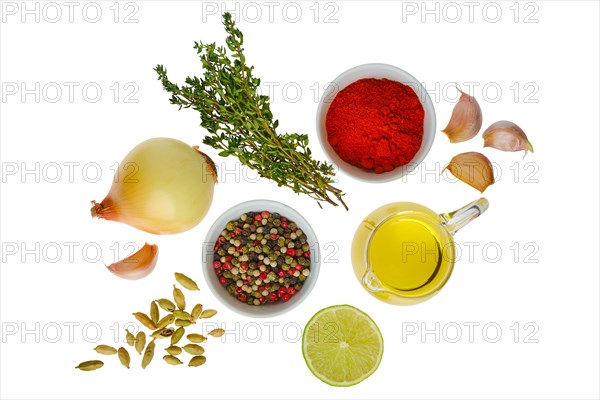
[0,1,599,399]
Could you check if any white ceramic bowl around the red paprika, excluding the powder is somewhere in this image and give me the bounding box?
[317,64,436,182]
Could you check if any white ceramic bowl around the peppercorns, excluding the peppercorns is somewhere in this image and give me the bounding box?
[202,200,320,317]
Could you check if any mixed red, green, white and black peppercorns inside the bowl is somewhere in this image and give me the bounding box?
[213,211,310,306]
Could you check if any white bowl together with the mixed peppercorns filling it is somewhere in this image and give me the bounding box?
[202,200,319,317]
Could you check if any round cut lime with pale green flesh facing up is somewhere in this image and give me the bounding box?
[302,305,383,386]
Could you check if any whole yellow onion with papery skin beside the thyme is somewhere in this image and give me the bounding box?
[91,138,217,234]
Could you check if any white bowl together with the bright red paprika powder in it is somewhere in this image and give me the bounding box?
[317,64,436,182]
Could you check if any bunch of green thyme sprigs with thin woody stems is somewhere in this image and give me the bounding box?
[154,13,348,209]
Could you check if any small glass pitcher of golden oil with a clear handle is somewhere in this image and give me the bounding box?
[352,197,489,305]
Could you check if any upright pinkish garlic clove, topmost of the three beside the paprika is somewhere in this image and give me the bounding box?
[442,89,483,143]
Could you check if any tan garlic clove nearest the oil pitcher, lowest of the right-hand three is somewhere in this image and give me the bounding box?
[442,151,494,193]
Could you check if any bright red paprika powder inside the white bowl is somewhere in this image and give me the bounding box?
[325,79,425,174]
